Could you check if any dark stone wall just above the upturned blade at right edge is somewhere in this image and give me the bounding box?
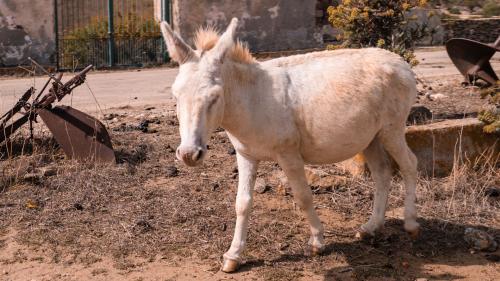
[443,18,500,43]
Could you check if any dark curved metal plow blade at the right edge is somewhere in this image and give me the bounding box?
[446,37,500,85]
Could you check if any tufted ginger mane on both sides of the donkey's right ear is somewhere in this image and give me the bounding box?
[193,26,256,64]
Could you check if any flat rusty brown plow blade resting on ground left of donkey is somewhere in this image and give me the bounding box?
[38,106,115,162]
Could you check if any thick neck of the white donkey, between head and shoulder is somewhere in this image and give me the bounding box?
[222,60,291,149]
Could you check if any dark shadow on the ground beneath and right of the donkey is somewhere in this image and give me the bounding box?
[241,219,500,280]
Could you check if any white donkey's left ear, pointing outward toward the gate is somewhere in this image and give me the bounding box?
[160,21,195,64]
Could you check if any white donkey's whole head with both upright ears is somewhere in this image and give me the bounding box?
[161,18,238,166]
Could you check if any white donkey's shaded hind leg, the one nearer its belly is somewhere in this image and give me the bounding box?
[356,137,391,238]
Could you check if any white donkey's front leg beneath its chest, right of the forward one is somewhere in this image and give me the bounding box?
[278,152,325,255]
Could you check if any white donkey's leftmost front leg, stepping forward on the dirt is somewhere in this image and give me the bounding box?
[222,153,259,272]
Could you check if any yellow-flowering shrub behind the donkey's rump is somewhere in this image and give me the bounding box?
[328,0,429,65]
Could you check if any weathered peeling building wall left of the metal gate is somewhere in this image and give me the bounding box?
[0,0,55,66]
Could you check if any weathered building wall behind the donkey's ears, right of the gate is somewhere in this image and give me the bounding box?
[172,0,322,52]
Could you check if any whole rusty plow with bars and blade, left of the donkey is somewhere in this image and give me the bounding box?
[0,60,115,162]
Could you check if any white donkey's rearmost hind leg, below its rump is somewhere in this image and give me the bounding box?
[381,127,420,238]
